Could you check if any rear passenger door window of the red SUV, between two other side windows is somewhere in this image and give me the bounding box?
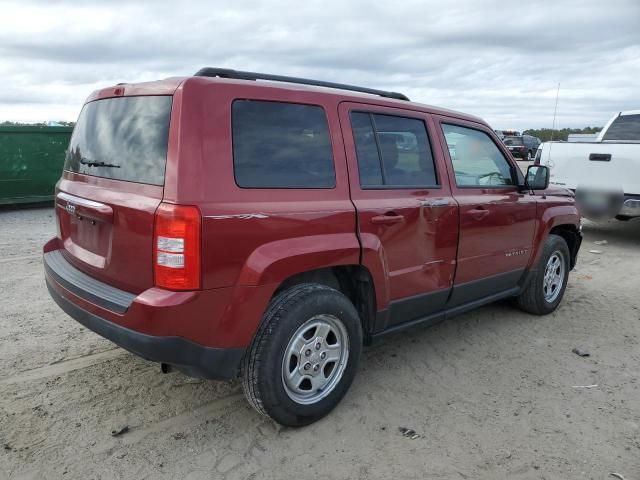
[351,112,438,188]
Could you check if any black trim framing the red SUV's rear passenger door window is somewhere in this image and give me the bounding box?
[349,108,442,190]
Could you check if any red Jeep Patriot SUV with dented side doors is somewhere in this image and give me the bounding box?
[44,68,582,425]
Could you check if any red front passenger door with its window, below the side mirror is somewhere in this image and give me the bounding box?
[438,117,536,307]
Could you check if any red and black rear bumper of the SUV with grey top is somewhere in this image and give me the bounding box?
[43,248,250,379]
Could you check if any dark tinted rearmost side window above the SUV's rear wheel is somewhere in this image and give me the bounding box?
[232,100,336,188]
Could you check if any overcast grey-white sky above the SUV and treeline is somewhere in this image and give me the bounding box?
[0,0,640,129]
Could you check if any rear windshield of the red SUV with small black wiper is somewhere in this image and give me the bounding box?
[64,96,172,185]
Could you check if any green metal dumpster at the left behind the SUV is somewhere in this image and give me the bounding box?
[0,125,73,205]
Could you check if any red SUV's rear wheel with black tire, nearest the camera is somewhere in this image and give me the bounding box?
[242,284,362,427]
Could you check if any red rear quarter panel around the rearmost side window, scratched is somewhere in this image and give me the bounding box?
[175,78,360,289]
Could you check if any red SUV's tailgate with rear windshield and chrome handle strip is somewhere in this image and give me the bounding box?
[56,95,172,293]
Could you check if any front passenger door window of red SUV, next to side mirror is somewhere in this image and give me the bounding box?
[442,124,514,187]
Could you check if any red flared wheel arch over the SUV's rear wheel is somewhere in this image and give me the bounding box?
[237,233,360,286]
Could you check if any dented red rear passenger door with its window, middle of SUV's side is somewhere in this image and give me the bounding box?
[340,103,458,331]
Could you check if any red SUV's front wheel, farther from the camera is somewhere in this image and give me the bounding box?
[516,234,570,315]
